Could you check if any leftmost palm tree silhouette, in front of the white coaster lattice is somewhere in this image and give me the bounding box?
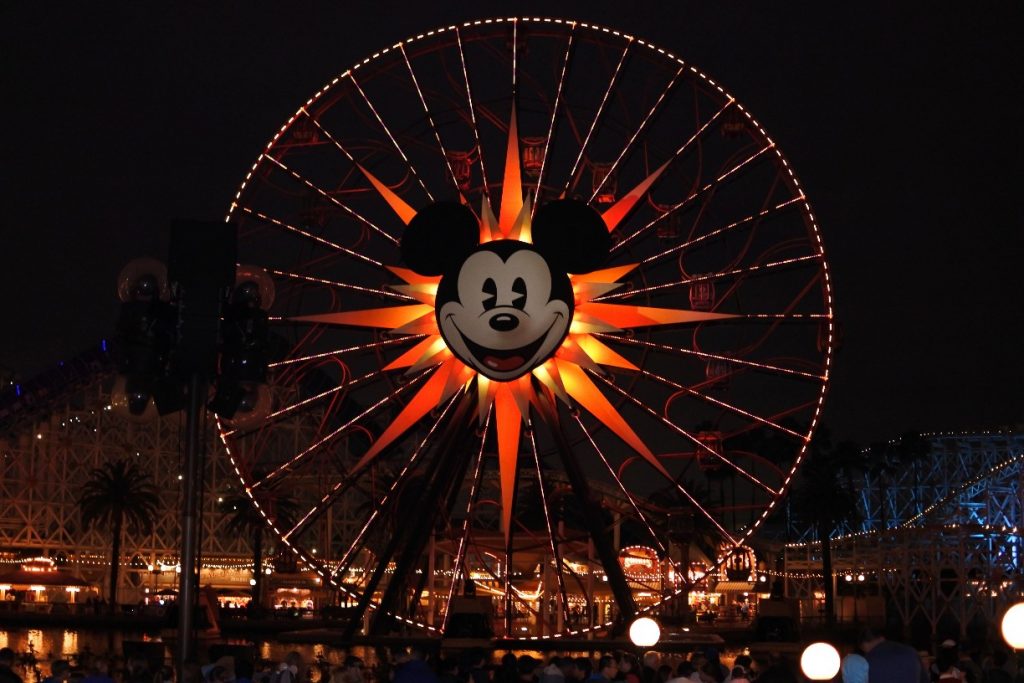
[78,460,160,613]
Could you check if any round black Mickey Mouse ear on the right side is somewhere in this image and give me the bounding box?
[530,200,611,273]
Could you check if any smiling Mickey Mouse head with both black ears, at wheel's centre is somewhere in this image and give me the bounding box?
[401,201,610,381]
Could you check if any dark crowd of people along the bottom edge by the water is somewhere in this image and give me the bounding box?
[0,629,1017,683]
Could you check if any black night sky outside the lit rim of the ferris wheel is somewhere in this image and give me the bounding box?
[0,0,1024,441]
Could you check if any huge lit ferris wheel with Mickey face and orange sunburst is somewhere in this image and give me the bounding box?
[220,17,834,637]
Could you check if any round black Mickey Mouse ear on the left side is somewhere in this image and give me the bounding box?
[401,202,480,275]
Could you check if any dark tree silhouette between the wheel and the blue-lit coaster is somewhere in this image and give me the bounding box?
[793,428,863,625]
